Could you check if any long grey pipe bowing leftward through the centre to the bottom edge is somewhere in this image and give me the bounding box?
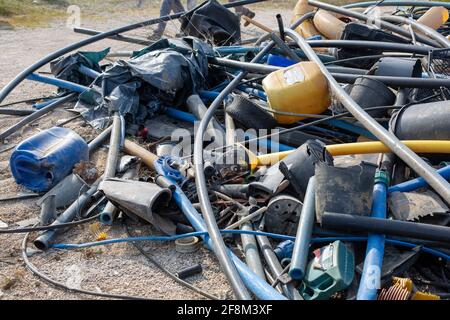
[194,15,314,300]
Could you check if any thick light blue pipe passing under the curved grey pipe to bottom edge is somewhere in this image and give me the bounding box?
[155,161,286,300]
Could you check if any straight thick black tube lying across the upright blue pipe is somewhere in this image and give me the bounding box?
[322,212,450,242]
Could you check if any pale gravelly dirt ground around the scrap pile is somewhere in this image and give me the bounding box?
[0,1,290,300]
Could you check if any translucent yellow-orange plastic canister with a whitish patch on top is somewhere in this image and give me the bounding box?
[263,61,331,124]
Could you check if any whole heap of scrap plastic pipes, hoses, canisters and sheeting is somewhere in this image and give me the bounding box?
[0,0,450,300]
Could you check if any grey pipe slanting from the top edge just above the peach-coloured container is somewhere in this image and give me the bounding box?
[308,0,436,47]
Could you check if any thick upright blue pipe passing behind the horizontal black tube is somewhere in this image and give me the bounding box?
[356,171,388,300]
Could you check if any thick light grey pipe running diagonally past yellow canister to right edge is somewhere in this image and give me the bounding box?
[285,29,450,203]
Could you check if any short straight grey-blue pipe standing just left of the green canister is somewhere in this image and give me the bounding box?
[289,177,316,280]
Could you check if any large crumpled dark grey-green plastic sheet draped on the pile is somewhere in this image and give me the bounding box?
[75,37,214,129]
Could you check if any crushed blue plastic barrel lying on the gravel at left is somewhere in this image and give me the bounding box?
[10,127,89,192]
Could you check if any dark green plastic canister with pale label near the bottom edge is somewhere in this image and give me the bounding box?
[299,241,355,300]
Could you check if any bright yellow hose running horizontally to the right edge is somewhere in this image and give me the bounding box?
[249,140,450,169]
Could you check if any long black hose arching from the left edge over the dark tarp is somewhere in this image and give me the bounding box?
[0,0,266,103]
